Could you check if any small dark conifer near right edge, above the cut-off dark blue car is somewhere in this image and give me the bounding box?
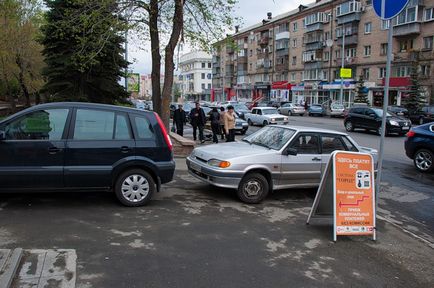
[402,61,426,113]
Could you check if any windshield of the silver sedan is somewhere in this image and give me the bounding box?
[243,126,295,150]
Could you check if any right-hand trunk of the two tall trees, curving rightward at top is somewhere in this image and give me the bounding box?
[161,0,184,131]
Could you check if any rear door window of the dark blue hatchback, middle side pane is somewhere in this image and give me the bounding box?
[72,109,115,140]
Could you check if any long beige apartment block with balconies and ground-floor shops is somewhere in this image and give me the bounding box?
[213,0,434,106]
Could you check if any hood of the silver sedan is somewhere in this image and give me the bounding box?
[191,142,273,161]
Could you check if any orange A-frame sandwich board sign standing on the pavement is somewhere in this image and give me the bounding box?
[307,151,376,241]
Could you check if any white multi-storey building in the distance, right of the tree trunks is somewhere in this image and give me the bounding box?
[178,51,212,101]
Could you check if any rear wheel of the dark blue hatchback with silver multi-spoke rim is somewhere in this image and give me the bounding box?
[114,169,156,207]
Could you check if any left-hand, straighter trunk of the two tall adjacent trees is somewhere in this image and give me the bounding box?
[149,0,162,119]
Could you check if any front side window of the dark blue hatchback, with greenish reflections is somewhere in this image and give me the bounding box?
[5,109,69,140]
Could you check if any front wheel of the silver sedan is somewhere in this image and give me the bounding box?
[237,173,270,204]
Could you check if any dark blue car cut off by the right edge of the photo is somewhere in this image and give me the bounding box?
[404,122,434,172]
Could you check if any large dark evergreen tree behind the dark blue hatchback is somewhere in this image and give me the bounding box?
[41,0,128,104]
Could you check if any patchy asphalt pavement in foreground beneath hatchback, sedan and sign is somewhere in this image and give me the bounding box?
[0,159,434,288]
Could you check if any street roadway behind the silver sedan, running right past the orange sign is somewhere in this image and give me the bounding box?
[242,116,434,245]
